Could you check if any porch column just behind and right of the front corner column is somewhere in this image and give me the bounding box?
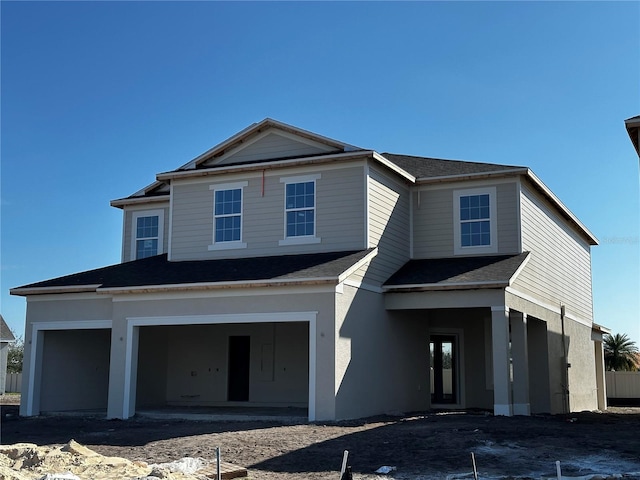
[509,310,531,415]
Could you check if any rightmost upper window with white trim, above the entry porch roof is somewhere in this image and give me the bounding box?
[453,187,498,255]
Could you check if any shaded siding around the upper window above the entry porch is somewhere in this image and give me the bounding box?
[412,182,520,258]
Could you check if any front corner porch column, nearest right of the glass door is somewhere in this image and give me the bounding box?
[491,305,513,416]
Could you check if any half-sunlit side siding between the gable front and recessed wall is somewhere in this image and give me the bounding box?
[366,168,410,283]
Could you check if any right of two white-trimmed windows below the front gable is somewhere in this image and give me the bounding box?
[280,174,320,245]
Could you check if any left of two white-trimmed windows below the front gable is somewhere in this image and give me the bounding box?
[209,182,247,250]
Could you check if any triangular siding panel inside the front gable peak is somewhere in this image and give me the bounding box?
[217,133,336,165]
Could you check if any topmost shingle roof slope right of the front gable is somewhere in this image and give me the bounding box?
[382,153,525,178]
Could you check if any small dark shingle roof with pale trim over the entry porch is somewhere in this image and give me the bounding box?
[383,252,529,291]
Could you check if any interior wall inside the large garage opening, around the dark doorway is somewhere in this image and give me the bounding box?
[137,322,309,407]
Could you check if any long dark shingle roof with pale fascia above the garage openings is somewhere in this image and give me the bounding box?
[11,248,377,295]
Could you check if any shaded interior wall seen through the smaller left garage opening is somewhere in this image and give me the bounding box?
[40,329,111,412]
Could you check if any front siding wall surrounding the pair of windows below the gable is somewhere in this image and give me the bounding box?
[171,166,365,260]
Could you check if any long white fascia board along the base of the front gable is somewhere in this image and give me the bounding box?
[156,150,374,180]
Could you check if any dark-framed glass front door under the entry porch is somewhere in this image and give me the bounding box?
[429,335,458,404]
